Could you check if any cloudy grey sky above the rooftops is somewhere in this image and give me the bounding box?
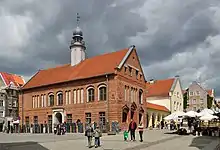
[0,0,220,96]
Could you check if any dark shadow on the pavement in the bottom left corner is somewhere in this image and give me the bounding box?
[0,142,48,150]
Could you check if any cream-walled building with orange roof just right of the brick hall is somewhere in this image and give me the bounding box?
[146,76,183,113]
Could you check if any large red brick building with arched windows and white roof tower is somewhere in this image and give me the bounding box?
[19,24,146,131]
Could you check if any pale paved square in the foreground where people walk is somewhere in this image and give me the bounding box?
[0,130,219,150]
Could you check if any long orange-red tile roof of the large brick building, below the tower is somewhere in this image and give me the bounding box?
[23,48,128,89]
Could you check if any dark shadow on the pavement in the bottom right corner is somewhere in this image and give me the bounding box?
[189,136,218,150]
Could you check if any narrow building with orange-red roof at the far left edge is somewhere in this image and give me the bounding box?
[0,72,25,131]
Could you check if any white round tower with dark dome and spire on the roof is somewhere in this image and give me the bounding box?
[70,13,86,66]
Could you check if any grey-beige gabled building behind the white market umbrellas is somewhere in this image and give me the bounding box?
[186,81,215,111]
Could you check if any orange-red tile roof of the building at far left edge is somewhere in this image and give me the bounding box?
[0,72,25,87]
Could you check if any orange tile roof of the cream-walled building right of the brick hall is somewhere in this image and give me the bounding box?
[146,78,175,97]
